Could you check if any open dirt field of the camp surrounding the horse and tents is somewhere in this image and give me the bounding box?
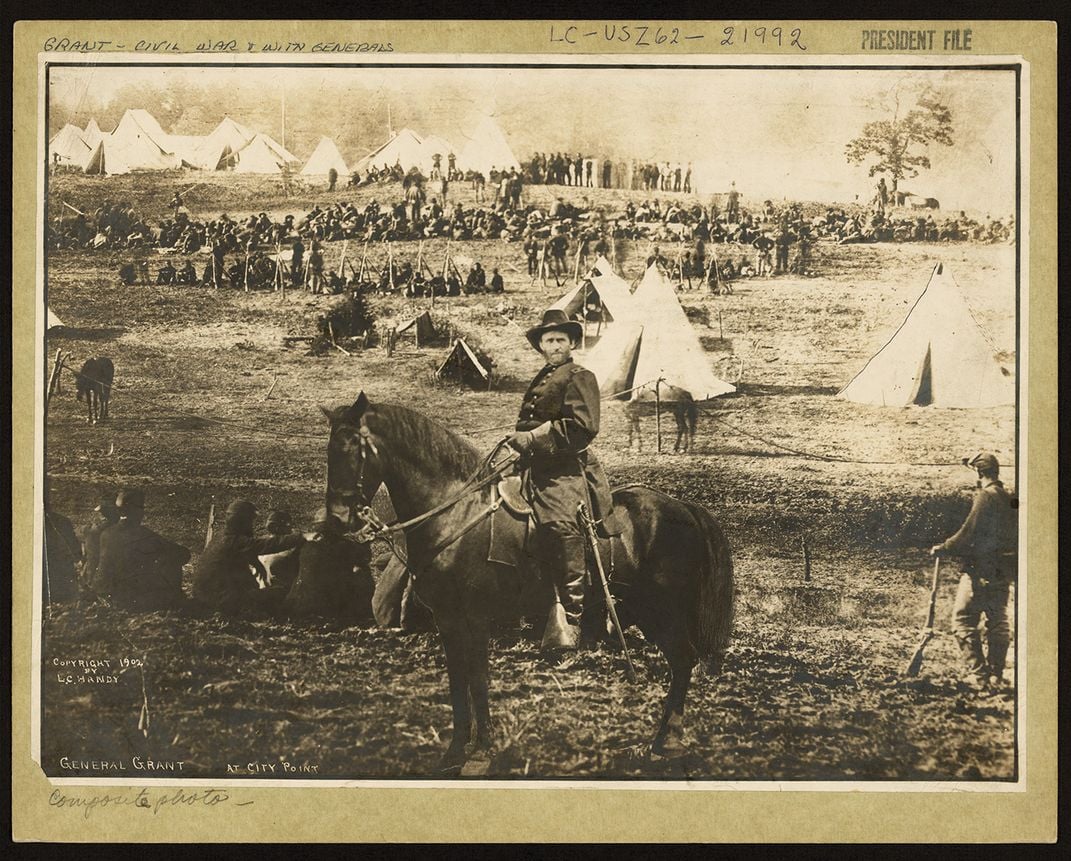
[43,177,1015,781]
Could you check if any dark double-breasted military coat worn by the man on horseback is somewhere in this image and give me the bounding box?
[517,359,618,534]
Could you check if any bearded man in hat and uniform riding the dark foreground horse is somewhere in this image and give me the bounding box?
[509,308,618,650]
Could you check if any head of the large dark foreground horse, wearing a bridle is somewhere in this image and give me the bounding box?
[320,392,382,530]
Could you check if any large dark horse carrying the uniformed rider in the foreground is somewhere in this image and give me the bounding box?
[323,392,733,771]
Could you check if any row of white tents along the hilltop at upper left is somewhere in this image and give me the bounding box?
[48,109,521,177]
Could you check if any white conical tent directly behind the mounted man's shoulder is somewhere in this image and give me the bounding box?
[584,265,736,401]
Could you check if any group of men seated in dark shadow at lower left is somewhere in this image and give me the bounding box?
[44,488,375,624]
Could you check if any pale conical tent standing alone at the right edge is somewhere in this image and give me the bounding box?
[836,263,1015,408]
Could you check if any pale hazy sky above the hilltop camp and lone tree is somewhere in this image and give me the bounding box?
[50,66,1015,216]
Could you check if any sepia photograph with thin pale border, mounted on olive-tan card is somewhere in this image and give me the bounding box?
[32,54,1023,791]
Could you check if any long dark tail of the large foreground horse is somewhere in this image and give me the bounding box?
[685,503,734,674]
